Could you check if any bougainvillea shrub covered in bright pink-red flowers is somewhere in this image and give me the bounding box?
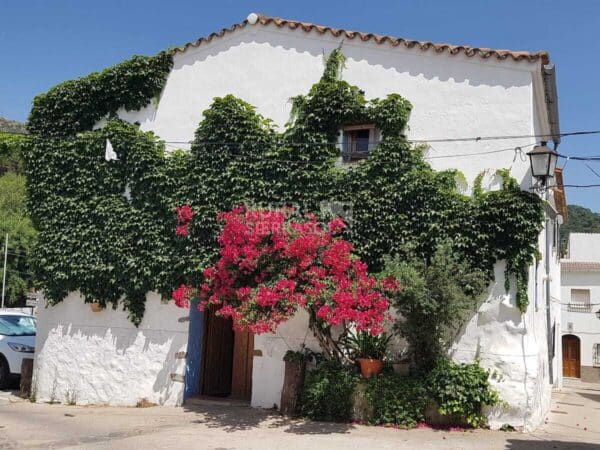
[173,206,399,357]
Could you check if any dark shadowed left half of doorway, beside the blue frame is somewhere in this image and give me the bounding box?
[202,310,234,397]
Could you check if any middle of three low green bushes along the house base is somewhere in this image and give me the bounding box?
[365,372,429,428]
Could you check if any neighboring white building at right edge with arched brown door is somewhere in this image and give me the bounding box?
[561,233,600,383]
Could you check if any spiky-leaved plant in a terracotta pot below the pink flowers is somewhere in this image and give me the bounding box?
[343,331,391,378]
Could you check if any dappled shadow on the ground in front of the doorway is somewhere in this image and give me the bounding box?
[180,405,353,435]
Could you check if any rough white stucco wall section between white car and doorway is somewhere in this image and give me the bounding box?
[33,293,188,406]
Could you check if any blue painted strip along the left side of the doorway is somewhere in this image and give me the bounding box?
[183,301,204,402]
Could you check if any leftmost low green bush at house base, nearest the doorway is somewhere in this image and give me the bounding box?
[301,361,358,422]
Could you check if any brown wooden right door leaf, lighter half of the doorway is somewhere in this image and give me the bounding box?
[231,331,254,400]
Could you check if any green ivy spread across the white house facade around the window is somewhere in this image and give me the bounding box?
[25,49,542,324]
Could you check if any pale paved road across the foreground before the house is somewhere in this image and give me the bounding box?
[0,385,600,450]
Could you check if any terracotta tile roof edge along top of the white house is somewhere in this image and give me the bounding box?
[175,14,550,64]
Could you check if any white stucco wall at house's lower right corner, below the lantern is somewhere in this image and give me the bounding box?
[450,218,560,430]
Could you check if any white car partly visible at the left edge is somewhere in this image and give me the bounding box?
[0,311,36,389]
